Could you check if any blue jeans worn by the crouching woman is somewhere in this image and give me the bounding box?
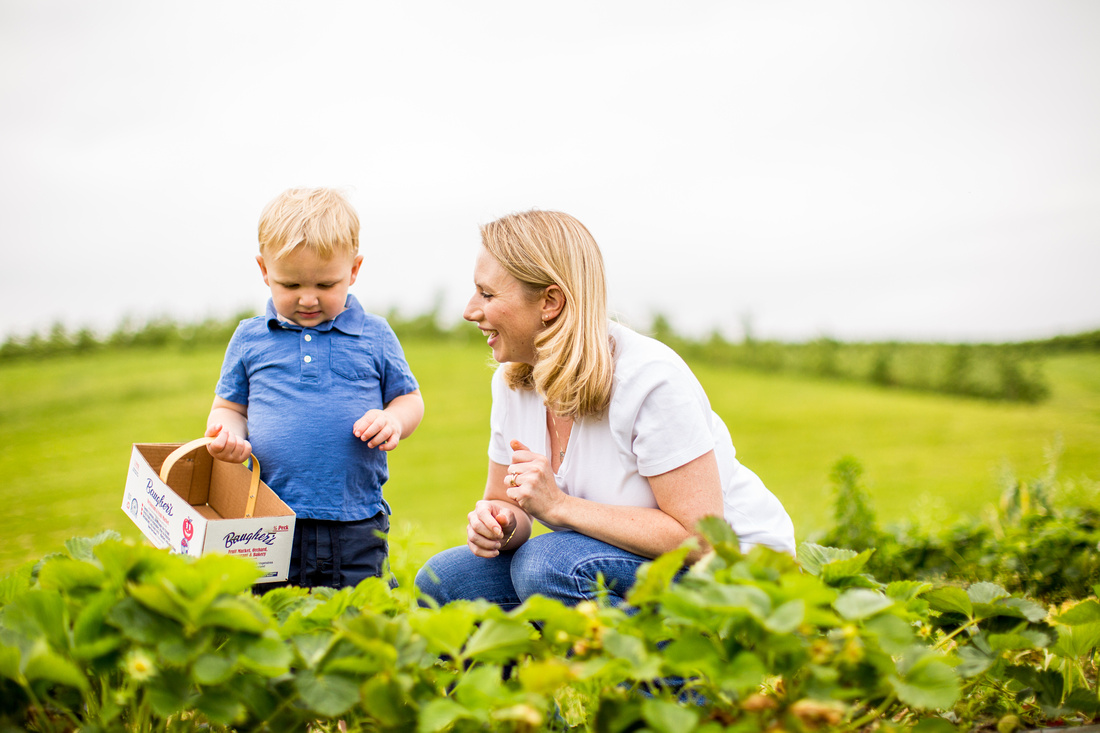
[416,530,649,611]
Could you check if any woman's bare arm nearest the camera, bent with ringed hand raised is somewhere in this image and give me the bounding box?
[506,441,723,561]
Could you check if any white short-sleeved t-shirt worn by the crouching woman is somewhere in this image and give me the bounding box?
[488,322,795,554]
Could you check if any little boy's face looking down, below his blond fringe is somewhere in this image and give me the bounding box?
[256,247,363,327]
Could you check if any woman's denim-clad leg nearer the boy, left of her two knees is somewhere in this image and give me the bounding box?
[416,545,520,610]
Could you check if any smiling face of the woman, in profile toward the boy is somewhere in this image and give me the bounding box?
[462,248,543,365]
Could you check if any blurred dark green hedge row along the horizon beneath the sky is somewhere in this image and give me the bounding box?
[0,308,1100,403]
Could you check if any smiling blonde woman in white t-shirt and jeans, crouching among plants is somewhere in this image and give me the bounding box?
[417,210,794,609]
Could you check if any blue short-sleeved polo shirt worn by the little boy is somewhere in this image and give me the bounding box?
[216,295,417,522]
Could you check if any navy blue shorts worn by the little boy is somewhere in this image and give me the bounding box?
[256,512,389,593]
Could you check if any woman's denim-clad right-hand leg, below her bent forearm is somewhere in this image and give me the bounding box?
[512,532,649,605]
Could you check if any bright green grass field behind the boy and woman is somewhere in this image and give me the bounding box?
[0,341,1100,572]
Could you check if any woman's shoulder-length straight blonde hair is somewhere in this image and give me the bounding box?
[481,210,613,417]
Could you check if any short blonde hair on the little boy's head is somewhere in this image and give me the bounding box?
[260,188,359,260]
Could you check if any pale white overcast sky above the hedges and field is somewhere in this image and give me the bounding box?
[0,0,1100,340]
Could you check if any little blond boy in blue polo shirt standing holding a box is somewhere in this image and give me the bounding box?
[206,188,424,591]
